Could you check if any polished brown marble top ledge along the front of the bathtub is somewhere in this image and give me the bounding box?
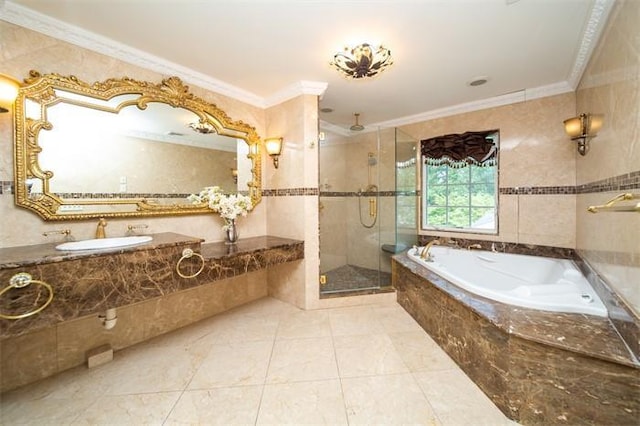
[393,254,640,369]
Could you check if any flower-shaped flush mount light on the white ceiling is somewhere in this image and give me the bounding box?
[331,43,393,79]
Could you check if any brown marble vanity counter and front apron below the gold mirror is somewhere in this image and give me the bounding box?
[0,233,304,338]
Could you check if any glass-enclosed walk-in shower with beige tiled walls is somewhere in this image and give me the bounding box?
[320,125,417,297]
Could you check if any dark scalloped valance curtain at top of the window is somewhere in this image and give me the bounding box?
[420,130,498,168]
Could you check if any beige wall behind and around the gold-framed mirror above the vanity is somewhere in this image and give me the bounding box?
[0,21,268,247]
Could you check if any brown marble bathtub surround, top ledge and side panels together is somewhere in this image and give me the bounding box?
[393,254,640,425]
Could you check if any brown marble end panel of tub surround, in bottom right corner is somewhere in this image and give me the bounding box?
[507,337,640,426]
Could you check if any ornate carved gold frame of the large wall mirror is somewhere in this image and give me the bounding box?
[14,71,262,220]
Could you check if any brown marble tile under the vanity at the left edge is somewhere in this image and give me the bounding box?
[0,327,57,392]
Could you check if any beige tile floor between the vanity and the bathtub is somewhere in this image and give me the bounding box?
[0,298,516,425]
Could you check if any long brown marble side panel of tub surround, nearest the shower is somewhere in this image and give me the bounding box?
[392,262,511,415]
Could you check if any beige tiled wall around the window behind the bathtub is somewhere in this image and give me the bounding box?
[401,93,576,248]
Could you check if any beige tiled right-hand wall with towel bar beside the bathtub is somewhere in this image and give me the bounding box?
[576,0,640,317]
